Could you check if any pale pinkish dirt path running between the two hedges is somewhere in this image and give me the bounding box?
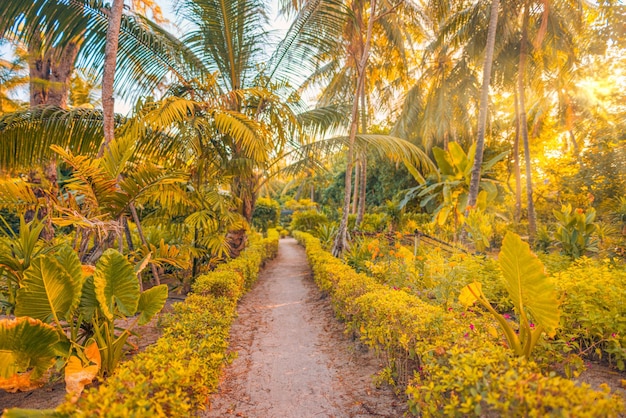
[204,238,405,418]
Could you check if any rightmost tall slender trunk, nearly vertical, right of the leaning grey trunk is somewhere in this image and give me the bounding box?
[517,4,537,242]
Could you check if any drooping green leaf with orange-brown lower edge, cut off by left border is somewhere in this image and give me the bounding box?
[0,317,59,392]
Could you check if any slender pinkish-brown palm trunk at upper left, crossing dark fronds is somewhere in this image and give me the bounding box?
[97,0,124,158]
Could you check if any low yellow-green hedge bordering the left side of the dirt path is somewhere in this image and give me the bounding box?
[51,230,279,418]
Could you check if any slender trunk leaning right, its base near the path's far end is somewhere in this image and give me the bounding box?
[332,0,376,257]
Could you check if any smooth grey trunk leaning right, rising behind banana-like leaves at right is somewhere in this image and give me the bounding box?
[467,0,500,207]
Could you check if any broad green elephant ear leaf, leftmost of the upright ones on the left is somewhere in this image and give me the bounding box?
[15,254,81,323]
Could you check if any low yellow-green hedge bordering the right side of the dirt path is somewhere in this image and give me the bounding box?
[294,232,624,417]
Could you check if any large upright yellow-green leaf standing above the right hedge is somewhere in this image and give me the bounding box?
[499,232,560,336]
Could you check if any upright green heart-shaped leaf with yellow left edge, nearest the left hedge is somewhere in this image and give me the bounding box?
[93,249,140,321]
